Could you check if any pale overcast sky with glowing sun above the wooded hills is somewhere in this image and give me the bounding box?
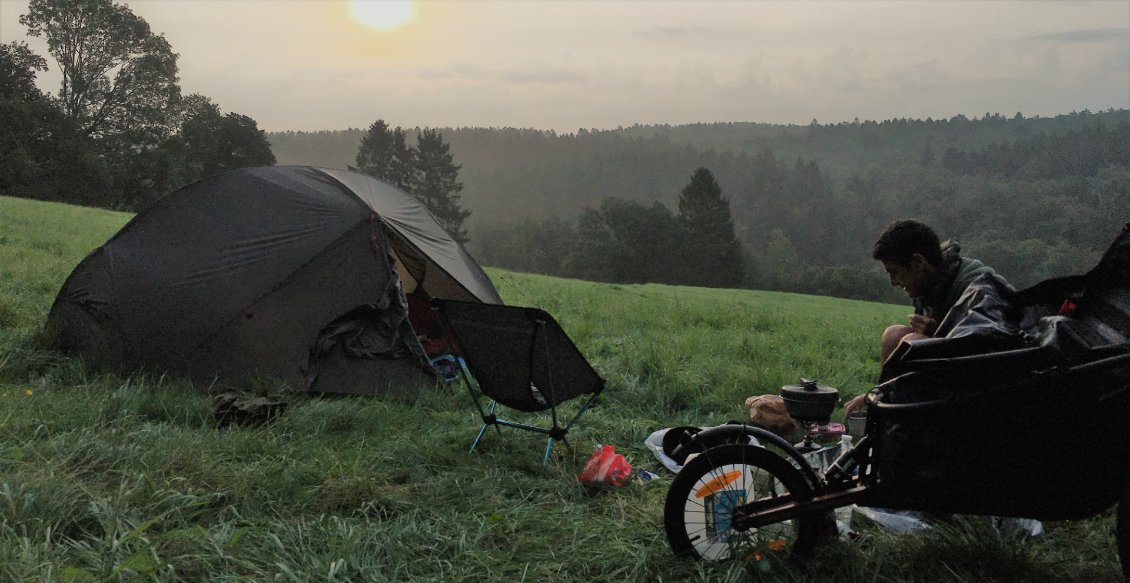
[0,0,1130,132]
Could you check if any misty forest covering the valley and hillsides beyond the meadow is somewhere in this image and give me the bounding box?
[268,110,1130,302]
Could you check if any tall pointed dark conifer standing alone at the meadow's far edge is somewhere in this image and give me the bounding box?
[678,168,742,287]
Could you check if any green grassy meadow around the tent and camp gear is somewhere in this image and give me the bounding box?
[0,197,1122,583]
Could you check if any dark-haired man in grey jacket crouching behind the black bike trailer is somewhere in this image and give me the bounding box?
[844,219,993,416]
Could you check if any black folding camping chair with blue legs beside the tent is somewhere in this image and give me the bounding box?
[432,299,605,465]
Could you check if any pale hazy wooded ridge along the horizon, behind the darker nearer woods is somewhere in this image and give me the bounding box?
[268,110,1130,224]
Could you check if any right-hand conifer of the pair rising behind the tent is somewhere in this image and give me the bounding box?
[411,130,471,243]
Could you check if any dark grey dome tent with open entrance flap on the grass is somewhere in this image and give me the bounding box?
[47,166,502,394]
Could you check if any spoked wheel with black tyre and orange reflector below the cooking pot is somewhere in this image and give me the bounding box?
[663,444,818,560]
